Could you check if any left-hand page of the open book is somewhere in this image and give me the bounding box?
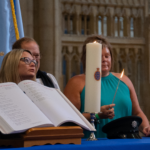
[0,82,52,133]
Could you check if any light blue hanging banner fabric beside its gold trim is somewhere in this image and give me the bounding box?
[0,0,24,65]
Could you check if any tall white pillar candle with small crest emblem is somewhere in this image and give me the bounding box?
[84,43,102,113]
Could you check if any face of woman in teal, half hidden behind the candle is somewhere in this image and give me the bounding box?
[102,47,111,77]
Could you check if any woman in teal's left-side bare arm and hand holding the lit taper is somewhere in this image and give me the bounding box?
[64,74,115,120]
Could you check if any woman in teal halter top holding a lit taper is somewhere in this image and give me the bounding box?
[64,35,150,137]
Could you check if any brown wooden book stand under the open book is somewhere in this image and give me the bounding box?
[0,126,84,147]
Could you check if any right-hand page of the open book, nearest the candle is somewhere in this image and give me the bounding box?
[19,80,94,130]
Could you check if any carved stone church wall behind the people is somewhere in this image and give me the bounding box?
[20,0,150,120]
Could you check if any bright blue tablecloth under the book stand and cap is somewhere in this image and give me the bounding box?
[0,137,150,150]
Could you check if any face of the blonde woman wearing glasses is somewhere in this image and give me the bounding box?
[18,52,36,81]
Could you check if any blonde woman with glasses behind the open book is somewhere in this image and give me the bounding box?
[0,49,37,84]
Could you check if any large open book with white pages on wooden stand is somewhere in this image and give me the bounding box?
[0,80,95,134]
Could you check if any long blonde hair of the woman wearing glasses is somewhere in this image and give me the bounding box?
[0,49,36,84]
